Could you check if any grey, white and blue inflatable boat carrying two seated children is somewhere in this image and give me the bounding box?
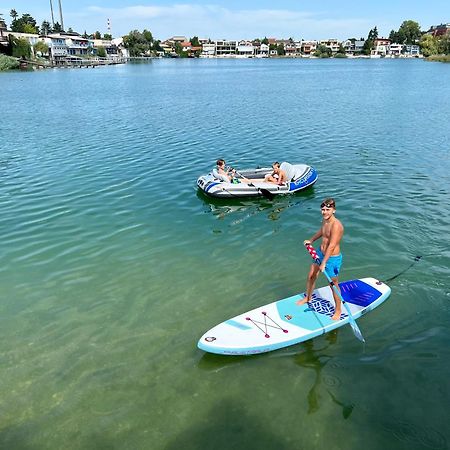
[197,162,318,198]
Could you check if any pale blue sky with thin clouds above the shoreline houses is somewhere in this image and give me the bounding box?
[0,0,450,40]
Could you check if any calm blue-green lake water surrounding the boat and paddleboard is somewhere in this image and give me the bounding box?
[0,60,450,450]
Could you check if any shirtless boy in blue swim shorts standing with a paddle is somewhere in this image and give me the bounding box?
[297,198,344,320]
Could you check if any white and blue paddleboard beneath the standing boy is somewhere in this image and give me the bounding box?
[198,278,391,355]
